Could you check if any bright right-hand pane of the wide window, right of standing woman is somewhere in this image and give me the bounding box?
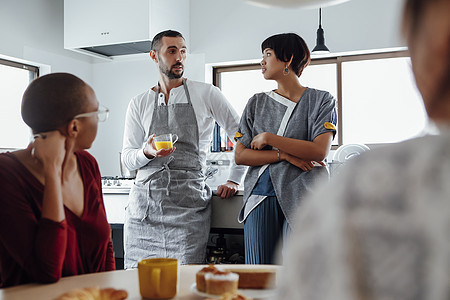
[341,56,427,144]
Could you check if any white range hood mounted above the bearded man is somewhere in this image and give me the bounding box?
[64,0,189,60]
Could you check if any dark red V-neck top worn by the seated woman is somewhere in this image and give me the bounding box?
[0,151,115,287]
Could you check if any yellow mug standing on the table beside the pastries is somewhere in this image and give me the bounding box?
[138,258,178,299]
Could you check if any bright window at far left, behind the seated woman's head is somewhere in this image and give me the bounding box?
[0,59,39,149]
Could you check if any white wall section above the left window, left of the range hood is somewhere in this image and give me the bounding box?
[0,0,92,83]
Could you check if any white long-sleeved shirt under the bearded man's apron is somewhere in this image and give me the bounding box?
[122,80,246,183]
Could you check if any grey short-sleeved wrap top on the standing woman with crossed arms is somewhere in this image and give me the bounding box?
[238,88,336,224]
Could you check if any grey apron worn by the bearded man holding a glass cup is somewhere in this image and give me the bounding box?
[124,79,211,268]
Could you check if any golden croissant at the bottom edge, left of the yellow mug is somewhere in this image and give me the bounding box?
[55,287,128,300]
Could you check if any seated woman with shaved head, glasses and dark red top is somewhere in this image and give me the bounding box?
[0,73,115,287]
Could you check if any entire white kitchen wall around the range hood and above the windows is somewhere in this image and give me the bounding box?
[0,0,404,176]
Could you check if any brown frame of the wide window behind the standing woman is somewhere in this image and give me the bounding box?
[212,48,410,150]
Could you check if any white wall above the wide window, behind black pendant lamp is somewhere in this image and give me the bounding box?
[191,0,404,63]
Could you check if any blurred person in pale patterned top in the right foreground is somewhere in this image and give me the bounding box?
[276,0,450,300]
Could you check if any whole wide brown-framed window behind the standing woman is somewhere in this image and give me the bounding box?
[213,51,428,148]
